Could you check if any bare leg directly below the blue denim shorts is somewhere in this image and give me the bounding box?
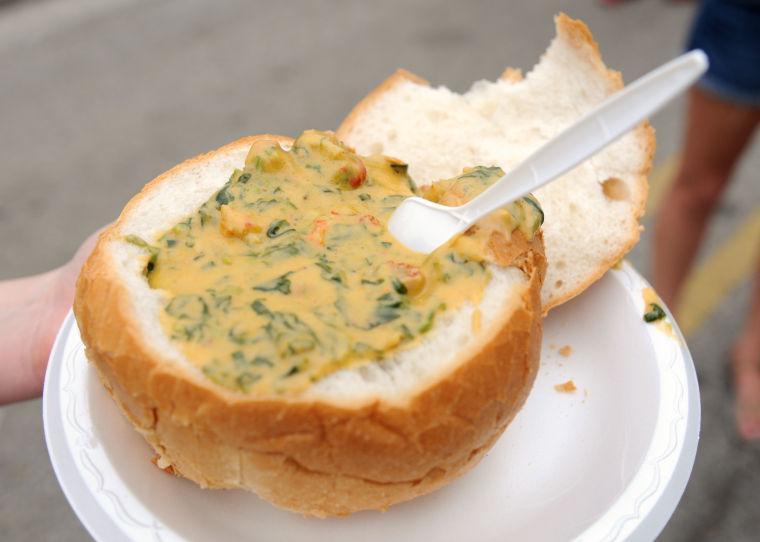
[653,89,760,310]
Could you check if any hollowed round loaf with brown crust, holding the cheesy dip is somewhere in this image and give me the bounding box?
[74,135,545,517]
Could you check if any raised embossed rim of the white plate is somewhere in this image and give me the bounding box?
[42,261,701,541]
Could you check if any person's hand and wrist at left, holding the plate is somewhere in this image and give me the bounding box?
[0,230,101,405]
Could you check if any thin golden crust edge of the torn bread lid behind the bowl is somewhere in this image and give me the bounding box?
[336,13,656,314]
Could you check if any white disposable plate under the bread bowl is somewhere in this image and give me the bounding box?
[43,264,700,542]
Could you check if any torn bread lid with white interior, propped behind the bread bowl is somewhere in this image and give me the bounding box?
[338,14,655,312]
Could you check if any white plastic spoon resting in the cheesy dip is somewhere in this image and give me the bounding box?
[388,50,708,253]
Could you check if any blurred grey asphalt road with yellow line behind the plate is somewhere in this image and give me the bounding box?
[0,0,760,542]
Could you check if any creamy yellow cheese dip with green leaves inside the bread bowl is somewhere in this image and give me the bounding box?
[132,131,543,394]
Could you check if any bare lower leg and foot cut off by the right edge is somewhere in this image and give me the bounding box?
[732,266,760,440]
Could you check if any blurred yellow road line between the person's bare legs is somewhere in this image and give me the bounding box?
[676,207,760,335]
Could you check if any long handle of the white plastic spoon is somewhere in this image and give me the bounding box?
[456,50,708,223]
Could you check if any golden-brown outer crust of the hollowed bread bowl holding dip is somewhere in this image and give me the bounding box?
[74,135,546,517]
